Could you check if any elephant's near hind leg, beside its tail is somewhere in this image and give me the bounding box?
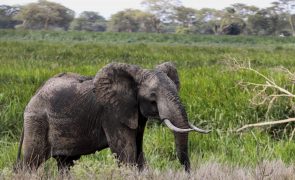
[23,115,50,171]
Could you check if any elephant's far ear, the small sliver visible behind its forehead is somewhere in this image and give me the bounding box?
[156,62,180,91]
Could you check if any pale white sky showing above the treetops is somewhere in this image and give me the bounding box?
[0,0,275,18]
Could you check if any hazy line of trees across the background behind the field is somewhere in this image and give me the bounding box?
[0,0,295,36]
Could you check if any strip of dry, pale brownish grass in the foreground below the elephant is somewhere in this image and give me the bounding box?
[0,160,295,180]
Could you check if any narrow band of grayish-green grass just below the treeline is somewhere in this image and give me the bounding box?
[0,30,295,45]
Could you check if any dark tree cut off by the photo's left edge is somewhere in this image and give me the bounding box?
[0,5,20,29]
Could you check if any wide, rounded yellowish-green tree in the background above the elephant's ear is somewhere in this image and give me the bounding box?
[109,9,160,32]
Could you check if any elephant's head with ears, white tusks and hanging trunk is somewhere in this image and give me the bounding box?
[94,62,208,171]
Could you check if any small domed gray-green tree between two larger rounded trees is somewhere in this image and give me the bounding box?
[71,11,107,31]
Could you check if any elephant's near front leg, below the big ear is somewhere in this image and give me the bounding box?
[104,124,137,165]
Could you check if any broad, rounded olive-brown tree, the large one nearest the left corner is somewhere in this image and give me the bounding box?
[15,0,75,30]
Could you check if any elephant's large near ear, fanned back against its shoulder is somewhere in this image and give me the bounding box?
[93,63,141,129]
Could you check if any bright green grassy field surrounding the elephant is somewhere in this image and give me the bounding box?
[0,30,295,179]
